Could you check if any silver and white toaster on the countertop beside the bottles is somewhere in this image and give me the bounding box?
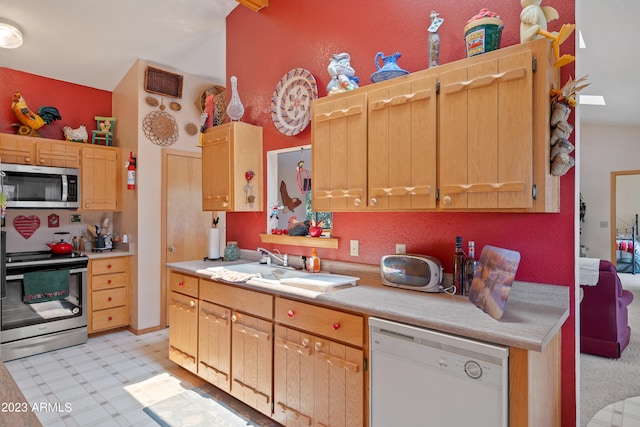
[380,254,444,292]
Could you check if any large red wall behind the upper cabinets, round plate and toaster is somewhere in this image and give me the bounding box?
[227,0,576,426]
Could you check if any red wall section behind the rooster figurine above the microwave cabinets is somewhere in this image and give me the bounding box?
[0,67,111,139]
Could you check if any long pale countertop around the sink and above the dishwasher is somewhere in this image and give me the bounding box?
[167,260,569,351]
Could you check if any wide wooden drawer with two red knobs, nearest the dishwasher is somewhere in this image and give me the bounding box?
[275,298,364,347]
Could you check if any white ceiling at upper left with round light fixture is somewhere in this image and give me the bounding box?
[0,0,238,91]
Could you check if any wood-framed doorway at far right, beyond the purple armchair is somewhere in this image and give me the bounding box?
[610,170,640,268]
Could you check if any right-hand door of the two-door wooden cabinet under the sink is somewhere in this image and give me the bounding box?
[231,312,273,416]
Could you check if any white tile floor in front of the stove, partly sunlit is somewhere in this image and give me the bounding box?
[5,329,228,427]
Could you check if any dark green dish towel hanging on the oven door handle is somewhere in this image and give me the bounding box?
[23,269,69,304]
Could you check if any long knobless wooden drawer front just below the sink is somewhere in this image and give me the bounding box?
[200,280,273,319]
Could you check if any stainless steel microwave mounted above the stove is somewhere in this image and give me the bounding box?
[0,164,80,209]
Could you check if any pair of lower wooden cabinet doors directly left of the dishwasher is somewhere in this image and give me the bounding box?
[273,326,364,427]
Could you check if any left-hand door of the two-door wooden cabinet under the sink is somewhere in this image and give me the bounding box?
[198,300,231,392]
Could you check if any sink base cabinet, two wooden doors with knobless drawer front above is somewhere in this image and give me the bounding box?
[198,280,273,416]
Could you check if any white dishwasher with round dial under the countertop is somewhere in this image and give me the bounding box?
[369,317,509,427]
